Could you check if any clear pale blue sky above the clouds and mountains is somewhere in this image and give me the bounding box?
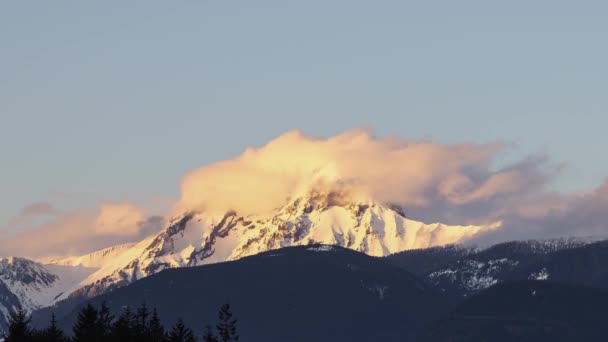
[0,0,608,225]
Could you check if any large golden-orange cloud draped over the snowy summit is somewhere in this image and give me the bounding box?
[177,129,552,219]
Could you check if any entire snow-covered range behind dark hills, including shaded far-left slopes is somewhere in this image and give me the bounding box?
[0,190,498,328]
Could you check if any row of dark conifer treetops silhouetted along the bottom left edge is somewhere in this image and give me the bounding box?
[4,303,239,342]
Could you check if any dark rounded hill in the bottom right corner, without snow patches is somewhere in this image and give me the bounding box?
[422,280,608,342]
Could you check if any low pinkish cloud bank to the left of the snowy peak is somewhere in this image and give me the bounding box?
[0,202,164,258]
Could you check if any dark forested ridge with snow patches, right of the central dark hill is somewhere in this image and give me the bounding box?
[387,238,596,302]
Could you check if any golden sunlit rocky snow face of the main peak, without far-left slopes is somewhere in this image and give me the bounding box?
[61,191,498,299]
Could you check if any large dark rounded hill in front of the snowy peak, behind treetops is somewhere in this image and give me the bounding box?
[34,245,447,341]
